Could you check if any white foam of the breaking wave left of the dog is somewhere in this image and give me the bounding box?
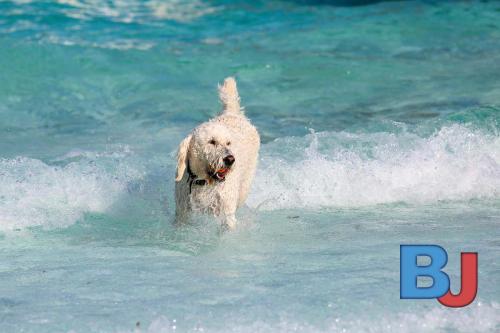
[0,153,141,231]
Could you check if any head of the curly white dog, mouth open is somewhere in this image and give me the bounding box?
[175,122,236,183]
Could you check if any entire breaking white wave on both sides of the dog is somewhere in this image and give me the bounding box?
[0,124,500,231]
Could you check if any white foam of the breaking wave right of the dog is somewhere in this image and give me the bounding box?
[248,124,500,210]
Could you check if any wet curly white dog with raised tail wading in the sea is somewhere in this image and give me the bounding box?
[175,77,260,228]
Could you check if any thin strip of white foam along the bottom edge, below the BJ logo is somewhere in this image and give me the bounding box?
[138,302,500,333]
